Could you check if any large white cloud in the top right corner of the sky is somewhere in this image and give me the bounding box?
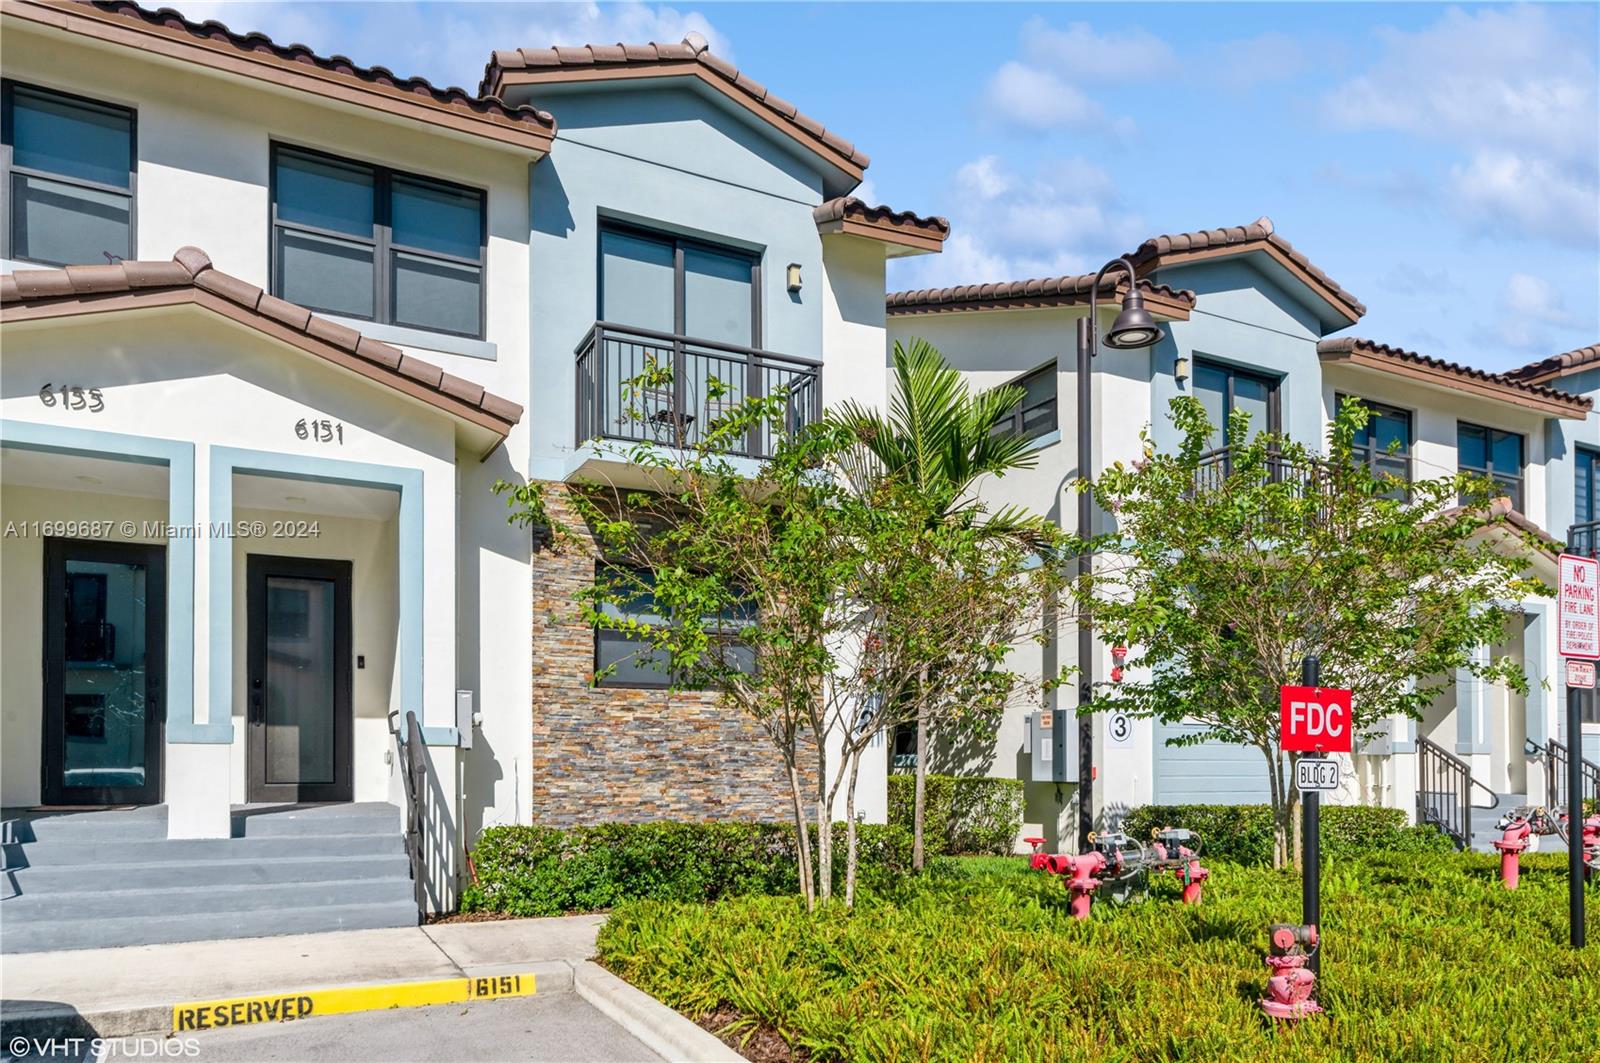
[1322,6,1600,248]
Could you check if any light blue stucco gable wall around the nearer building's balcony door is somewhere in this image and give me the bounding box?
[528,82,822,479]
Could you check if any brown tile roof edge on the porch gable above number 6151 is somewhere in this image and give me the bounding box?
[0,247,523,439]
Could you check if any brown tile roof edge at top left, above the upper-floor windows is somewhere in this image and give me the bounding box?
[5,0,555,150]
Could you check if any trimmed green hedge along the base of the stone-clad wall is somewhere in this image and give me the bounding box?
[461,823,910,916]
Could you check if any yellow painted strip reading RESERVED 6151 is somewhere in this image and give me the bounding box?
[173,972,536,1034]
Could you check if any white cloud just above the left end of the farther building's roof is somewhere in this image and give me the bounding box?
[890,155,1144,288]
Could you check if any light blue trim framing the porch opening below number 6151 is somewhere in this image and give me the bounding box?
[210,447,432,744]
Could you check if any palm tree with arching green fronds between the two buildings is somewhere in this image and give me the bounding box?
[834,339,1042,869]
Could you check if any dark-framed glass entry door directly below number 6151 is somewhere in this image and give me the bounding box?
[246,554,354,802]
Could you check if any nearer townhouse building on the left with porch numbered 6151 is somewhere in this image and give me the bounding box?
[0,0,949,951]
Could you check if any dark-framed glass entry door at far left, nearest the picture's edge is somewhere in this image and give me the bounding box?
[40,540,166,805]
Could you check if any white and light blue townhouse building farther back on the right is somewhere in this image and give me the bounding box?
[886,218,1600,845]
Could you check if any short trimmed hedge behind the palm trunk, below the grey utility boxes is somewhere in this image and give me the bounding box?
[890,775,1022,856]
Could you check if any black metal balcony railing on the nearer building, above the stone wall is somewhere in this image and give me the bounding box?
[576,322,822,458]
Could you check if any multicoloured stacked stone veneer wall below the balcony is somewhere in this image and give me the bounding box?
[531,483,794,826]
